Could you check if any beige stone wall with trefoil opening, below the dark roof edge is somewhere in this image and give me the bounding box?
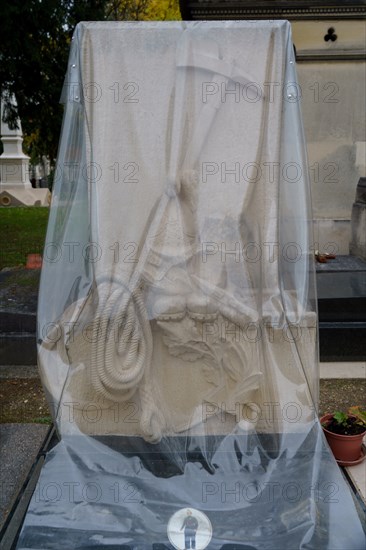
[292,17,366,254]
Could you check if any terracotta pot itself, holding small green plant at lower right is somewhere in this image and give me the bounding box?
[320,414,366,465]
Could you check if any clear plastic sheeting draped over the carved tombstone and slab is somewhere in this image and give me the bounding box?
[18,21,364,550]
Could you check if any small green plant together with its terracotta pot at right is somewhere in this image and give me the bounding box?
[320,406,366,466]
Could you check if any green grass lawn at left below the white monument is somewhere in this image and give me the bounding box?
[0,206,49,270]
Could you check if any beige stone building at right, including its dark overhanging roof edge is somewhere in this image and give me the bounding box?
[180,0,366,254]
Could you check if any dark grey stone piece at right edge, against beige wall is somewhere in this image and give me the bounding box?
[350,178,366,260]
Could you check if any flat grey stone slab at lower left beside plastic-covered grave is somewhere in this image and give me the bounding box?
[0,424,49,529]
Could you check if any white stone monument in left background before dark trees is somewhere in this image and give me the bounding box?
[0,97,50,206]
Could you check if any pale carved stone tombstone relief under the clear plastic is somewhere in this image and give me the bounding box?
[40,26,316,442]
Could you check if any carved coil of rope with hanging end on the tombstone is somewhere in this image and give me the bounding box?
[91,281,165,443]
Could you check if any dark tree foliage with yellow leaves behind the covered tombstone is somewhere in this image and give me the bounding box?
[0,0,181,177]
